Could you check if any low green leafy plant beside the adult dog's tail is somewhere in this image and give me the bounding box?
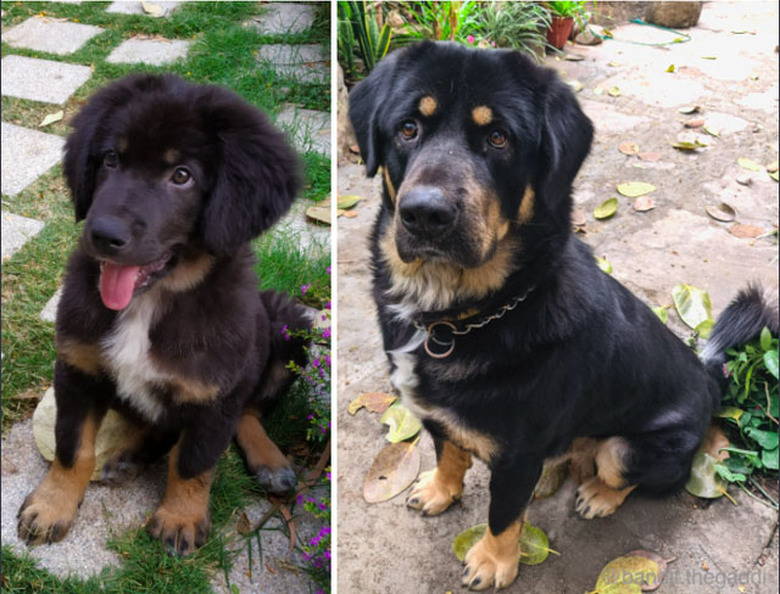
[716,328,778,498]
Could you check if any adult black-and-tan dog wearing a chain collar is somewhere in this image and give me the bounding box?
[349,42,777,589]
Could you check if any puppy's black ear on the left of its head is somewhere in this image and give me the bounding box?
[63,75,160,221]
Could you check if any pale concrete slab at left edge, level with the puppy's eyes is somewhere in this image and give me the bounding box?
[2,122,65,196]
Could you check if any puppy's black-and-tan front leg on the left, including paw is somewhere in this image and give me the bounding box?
[17,361,113,545]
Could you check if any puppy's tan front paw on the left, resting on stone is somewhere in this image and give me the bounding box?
[17,483,79,545]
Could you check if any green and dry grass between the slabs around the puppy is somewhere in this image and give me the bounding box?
[2,2,331,593]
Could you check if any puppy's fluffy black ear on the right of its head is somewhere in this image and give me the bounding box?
[199,87,301,254]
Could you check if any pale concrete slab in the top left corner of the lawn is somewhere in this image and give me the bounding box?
[3,16,103,56]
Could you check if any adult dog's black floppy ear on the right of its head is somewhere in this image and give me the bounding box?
[538,72,593,216]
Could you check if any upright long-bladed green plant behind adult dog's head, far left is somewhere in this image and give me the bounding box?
[338,0,391,74]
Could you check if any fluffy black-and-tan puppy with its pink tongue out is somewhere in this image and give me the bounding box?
[18,75,308,555]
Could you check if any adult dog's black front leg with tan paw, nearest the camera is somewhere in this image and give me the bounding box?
[463,454,542,590]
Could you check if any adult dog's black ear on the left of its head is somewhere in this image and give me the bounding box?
[349,50,404,177]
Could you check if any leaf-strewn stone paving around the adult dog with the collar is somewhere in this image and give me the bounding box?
[337,3,778,594]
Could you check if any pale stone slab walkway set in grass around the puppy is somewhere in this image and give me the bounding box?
[2,1,330,592]
